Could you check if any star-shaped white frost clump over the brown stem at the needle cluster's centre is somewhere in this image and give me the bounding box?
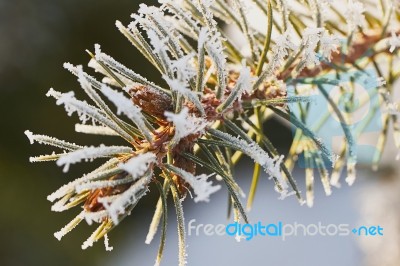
[164,107,208,144]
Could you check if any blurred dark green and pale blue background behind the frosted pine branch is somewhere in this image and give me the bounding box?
[0,0,400,266]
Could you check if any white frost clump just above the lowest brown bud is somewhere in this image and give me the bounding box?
[119,152,157,180]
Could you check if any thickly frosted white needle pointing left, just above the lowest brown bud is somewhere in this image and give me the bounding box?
[57,145,133,172]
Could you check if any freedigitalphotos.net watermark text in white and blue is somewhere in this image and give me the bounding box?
[187,219,383,241]
